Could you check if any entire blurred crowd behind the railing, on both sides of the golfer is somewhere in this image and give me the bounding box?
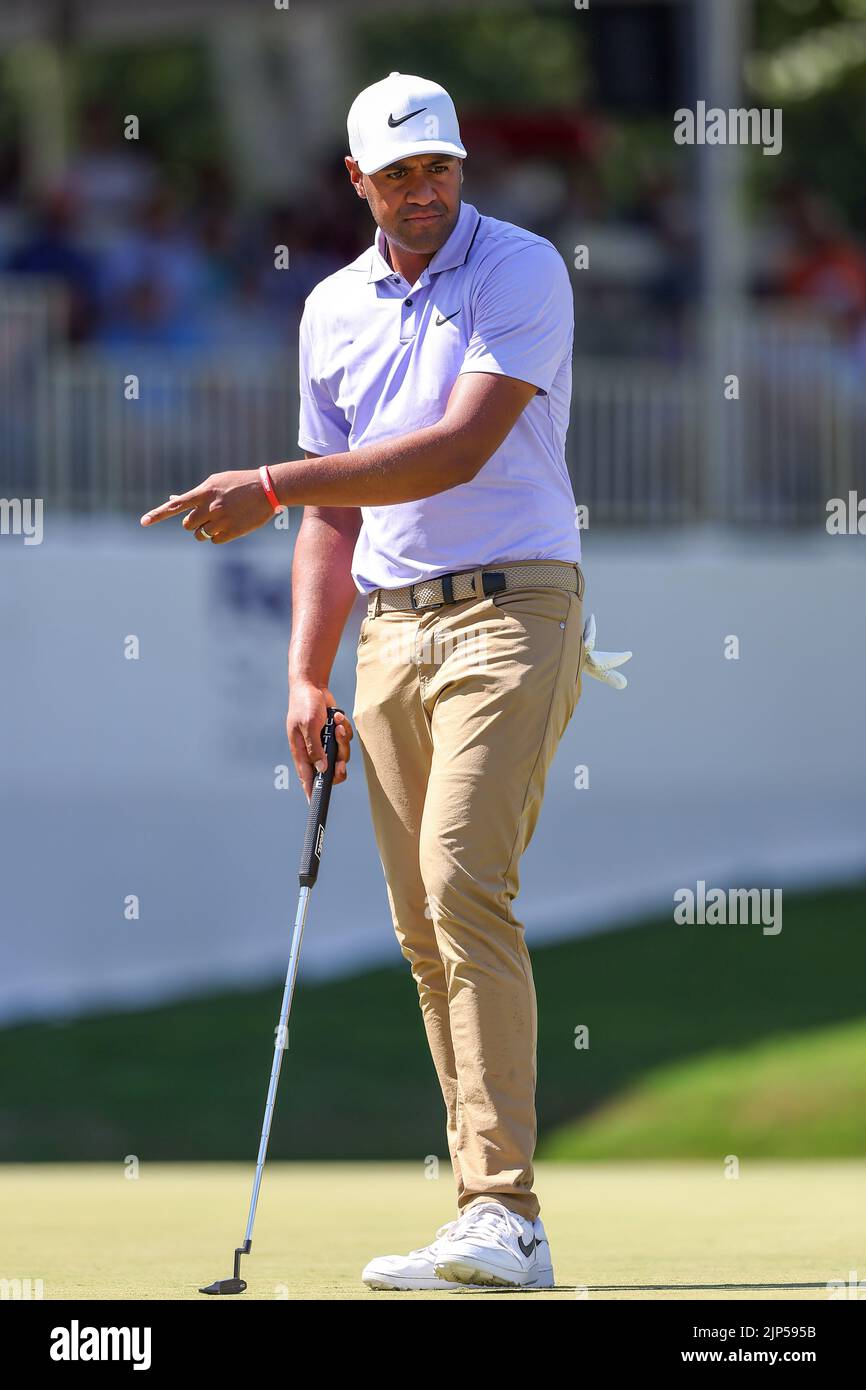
[0,107,866,359]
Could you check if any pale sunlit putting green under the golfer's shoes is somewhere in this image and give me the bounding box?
[0,1155,866,1295]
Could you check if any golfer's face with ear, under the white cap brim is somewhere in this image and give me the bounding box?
[346,154,463,256]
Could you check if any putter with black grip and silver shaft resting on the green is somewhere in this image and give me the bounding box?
[199,705,343,1294]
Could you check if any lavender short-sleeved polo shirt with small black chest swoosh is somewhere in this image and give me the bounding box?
[297,203,580,594]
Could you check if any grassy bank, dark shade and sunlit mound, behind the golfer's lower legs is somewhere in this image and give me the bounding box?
[0,885,866,1163]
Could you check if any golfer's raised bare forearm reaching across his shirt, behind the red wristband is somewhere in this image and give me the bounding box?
[268,421,470,507]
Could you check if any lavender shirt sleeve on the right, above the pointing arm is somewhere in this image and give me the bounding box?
[460,242,574,395]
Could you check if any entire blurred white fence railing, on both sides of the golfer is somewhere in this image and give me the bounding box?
[0,278,866,525]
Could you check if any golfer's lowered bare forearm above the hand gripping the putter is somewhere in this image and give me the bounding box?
[289,508,357,685]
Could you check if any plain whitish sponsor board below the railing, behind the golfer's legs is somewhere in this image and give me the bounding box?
[0,513,866,1020]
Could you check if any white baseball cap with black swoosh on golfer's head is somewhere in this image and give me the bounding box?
[346,72,466,174]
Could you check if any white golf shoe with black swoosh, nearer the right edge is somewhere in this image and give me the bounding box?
[434,1200,553,1289]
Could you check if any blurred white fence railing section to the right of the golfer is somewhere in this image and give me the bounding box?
[569,314,866,525]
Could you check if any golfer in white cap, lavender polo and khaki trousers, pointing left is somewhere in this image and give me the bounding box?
[142,72,630,1289]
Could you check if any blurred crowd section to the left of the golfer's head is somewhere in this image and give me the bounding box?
[0,111,366,353]
